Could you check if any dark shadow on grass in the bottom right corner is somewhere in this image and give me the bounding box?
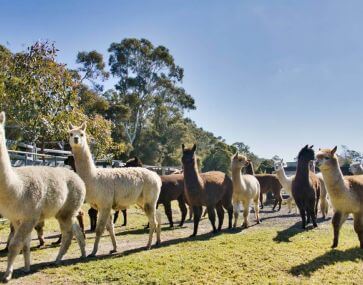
[289,248,363,276]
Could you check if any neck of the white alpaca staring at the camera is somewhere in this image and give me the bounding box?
[73,143,96,180]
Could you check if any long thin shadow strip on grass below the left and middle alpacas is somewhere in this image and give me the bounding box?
[0,228,242,279]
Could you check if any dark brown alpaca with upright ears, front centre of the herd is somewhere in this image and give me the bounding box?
[182,144,233,237]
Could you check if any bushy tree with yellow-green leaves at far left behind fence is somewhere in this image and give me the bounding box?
[0,42,77,144]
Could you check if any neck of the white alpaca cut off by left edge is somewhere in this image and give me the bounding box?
[0,134,21,199]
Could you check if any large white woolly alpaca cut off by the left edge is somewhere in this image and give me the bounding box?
[0,112,86,282]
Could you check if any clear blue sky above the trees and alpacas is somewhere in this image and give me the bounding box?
[0,0,363,161]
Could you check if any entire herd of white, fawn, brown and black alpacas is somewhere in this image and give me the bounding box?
[0,112,363,282]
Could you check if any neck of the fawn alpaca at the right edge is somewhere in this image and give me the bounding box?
[321,161,345,198]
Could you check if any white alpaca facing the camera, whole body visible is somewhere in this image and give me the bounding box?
[69,123,161,256]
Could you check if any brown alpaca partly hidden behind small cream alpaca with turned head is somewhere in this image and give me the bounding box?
[246,160,282,211]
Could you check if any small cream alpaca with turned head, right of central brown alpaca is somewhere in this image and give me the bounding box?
[231,152,260,228]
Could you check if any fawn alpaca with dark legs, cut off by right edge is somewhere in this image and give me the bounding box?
[316,147,363,248]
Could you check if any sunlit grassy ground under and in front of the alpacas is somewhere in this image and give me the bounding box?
[0,202,363,284]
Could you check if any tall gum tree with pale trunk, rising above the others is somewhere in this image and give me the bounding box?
[108,38,195,149]
